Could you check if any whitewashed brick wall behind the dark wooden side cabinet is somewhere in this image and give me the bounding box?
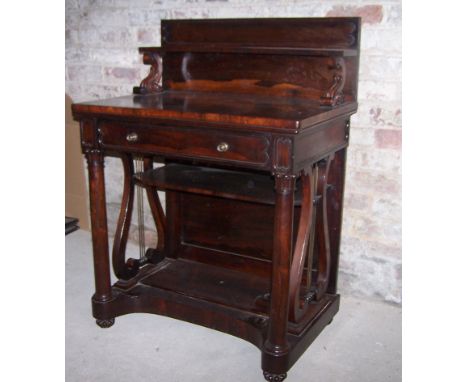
[66,0,401,303]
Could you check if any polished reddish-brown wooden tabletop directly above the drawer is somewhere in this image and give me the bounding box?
[72,90,357,132]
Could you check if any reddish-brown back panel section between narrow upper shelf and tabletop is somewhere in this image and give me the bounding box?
[164,53,340,99]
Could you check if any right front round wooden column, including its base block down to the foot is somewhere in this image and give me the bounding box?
[262,175,295,378]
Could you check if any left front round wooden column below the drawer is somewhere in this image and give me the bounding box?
[86,150,112,302]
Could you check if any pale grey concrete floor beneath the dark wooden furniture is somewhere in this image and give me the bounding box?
[65,230,401,382]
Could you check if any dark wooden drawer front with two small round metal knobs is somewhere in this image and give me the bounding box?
[99,122,270,165]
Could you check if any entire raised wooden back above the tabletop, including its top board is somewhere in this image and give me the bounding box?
[162,18,360,101]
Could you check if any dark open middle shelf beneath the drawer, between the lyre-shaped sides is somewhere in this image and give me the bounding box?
[135,164,301,205]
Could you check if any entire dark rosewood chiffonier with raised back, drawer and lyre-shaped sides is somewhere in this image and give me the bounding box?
[72,18,360,381]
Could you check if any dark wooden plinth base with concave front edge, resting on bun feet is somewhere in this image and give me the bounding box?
[93,259,339,381]
